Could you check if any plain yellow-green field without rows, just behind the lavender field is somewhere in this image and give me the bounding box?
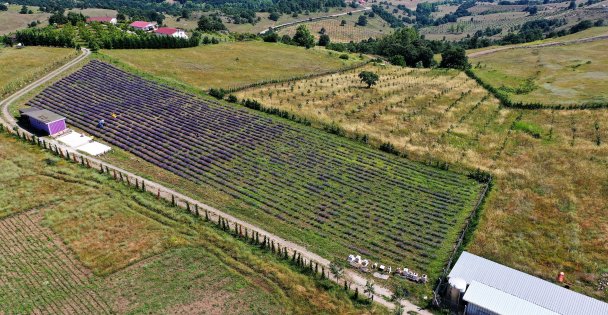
[103,42,362,89]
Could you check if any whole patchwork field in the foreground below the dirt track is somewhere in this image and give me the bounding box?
[0,134,385,314]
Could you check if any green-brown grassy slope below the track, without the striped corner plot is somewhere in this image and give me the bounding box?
[0,134,382,313]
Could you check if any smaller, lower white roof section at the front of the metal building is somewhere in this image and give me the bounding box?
[462,281,558,315]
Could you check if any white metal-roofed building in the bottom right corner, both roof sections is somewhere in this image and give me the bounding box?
[448,252,608,315]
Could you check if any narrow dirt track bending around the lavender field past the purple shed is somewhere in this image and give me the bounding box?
[0,48,431,315]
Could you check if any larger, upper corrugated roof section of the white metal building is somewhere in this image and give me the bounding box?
[448,252,608,315]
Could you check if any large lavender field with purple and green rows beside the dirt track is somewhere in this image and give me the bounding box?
[30,61,481,292]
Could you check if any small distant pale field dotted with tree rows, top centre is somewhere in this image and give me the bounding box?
[278,12,392,43]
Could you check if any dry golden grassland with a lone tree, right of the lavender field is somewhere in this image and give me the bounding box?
[238,65,608,300]
